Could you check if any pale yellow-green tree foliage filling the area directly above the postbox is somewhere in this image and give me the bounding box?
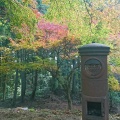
[45,0,120,109]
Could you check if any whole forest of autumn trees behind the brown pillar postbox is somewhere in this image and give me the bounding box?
[0,0,120,114]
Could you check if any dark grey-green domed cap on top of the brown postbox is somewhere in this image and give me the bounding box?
[79,43,110,55]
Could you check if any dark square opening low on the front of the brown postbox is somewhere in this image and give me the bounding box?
[87,101,102,116]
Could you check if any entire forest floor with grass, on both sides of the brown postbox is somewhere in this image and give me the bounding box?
[0,99,120,120]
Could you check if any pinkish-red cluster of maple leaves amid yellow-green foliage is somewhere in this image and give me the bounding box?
[38,20,68,42]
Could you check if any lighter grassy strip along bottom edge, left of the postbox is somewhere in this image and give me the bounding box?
[0,108,81,120]
